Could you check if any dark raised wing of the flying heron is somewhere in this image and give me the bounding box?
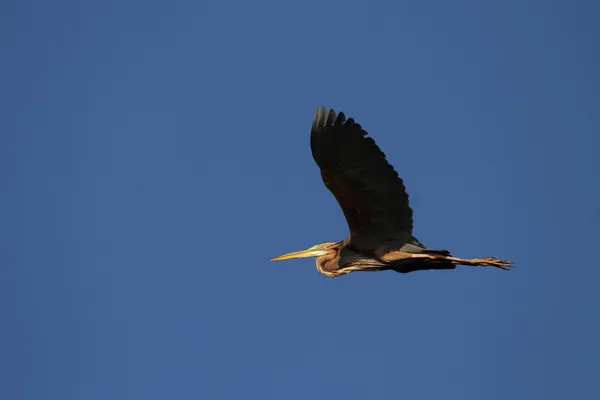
[310,107,413,252]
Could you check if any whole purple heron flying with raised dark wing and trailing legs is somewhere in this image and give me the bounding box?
[271,107,513,278]
